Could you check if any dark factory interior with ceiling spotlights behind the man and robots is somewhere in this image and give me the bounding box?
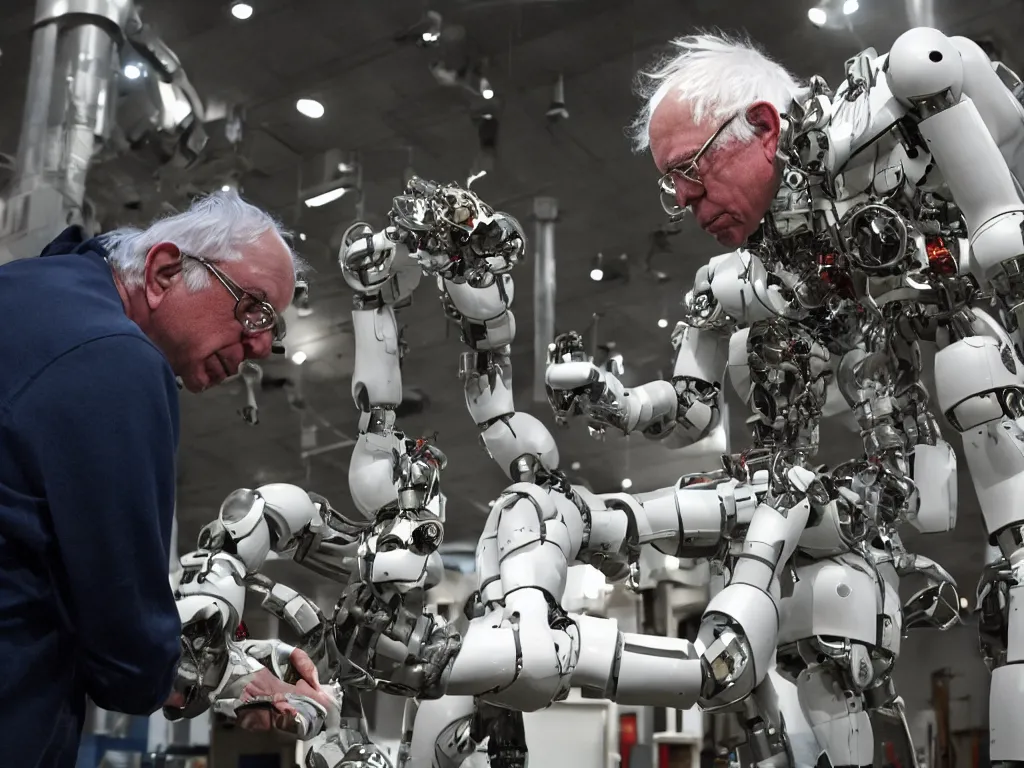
[0,0,1007,768]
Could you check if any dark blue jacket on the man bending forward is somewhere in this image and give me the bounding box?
[0,227,180,768]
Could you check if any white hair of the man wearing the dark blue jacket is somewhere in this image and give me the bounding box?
[99,189,307,291]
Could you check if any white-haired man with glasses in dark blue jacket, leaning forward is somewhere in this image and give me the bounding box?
[0,194,311,768]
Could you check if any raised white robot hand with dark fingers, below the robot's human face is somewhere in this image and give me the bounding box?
[544,331,639,433]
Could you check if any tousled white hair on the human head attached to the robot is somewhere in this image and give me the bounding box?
[630,33,807,153]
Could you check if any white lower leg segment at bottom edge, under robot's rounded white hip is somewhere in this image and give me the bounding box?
[797,665,874,768]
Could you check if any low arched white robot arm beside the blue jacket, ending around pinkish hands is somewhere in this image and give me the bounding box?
[164,483,389,768]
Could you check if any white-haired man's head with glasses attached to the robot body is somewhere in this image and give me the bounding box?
[633,35,806,248]
